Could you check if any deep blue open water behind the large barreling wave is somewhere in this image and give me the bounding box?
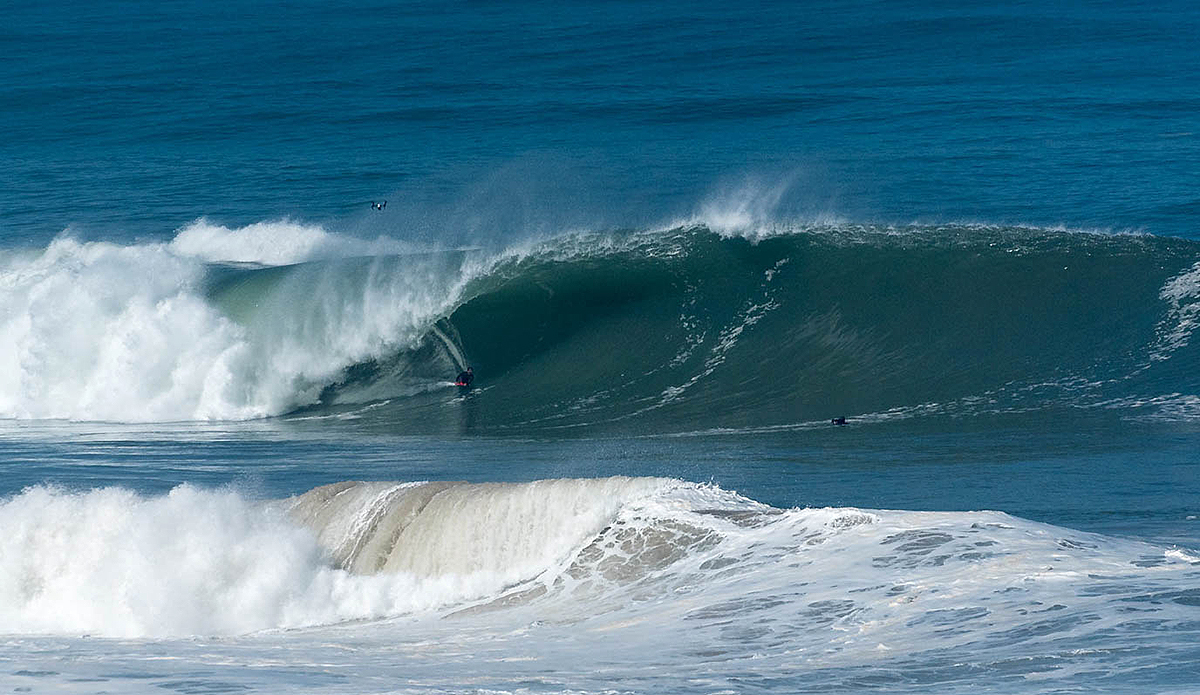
[0,1,1200,242]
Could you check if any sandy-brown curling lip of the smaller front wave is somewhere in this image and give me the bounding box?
[289,478,666,578]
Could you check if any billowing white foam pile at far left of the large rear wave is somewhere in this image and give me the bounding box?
[0,239,253,420]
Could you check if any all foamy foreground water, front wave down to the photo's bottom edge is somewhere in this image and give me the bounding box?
[7,478,1200,691]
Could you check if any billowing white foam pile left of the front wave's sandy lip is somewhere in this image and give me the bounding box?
[0,486,350,636]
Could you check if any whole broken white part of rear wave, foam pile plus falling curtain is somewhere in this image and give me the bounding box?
[0,232,467,421]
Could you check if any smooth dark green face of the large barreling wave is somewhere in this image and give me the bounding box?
[214,226,1200,433]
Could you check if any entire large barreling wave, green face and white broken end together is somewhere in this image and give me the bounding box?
[0,221,1200,432]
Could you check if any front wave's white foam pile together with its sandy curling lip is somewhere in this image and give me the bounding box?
[0,479,664,636]
